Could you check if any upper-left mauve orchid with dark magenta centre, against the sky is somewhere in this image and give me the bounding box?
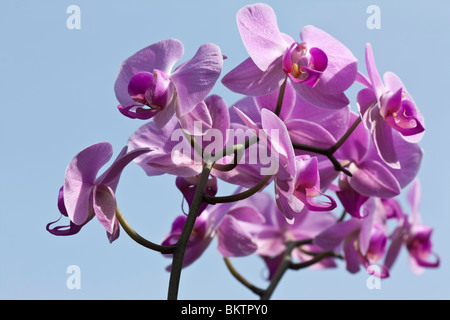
[114,39,223,128]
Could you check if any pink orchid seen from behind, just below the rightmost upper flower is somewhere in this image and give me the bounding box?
[320,113,423,202]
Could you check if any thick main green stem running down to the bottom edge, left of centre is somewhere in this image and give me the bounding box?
[167,162,214,300]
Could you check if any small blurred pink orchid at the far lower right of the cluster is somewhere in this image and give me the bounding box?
[385,179,440,274]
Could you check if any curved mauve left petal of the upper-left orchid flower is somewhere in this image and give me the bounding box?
[114,39,184,106]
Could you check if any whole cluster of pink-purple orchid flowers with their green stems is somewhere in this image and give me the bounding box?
[47,4,439,298]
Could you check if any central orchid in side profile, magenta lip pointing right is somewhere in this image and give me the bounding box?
[236,109,336,222]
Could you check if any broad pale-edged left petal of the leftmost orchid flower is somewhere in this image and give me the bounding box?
[63,142,113,225]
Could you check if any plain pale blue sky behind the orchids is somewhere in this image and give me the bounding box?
[0,0,450,299]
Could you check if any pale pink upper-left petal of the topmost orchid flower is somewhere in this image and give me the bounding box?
[236,3,289,71]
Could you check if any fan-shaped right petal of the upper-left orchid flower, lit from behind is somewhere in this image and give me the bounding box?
[170,43,223,116]
